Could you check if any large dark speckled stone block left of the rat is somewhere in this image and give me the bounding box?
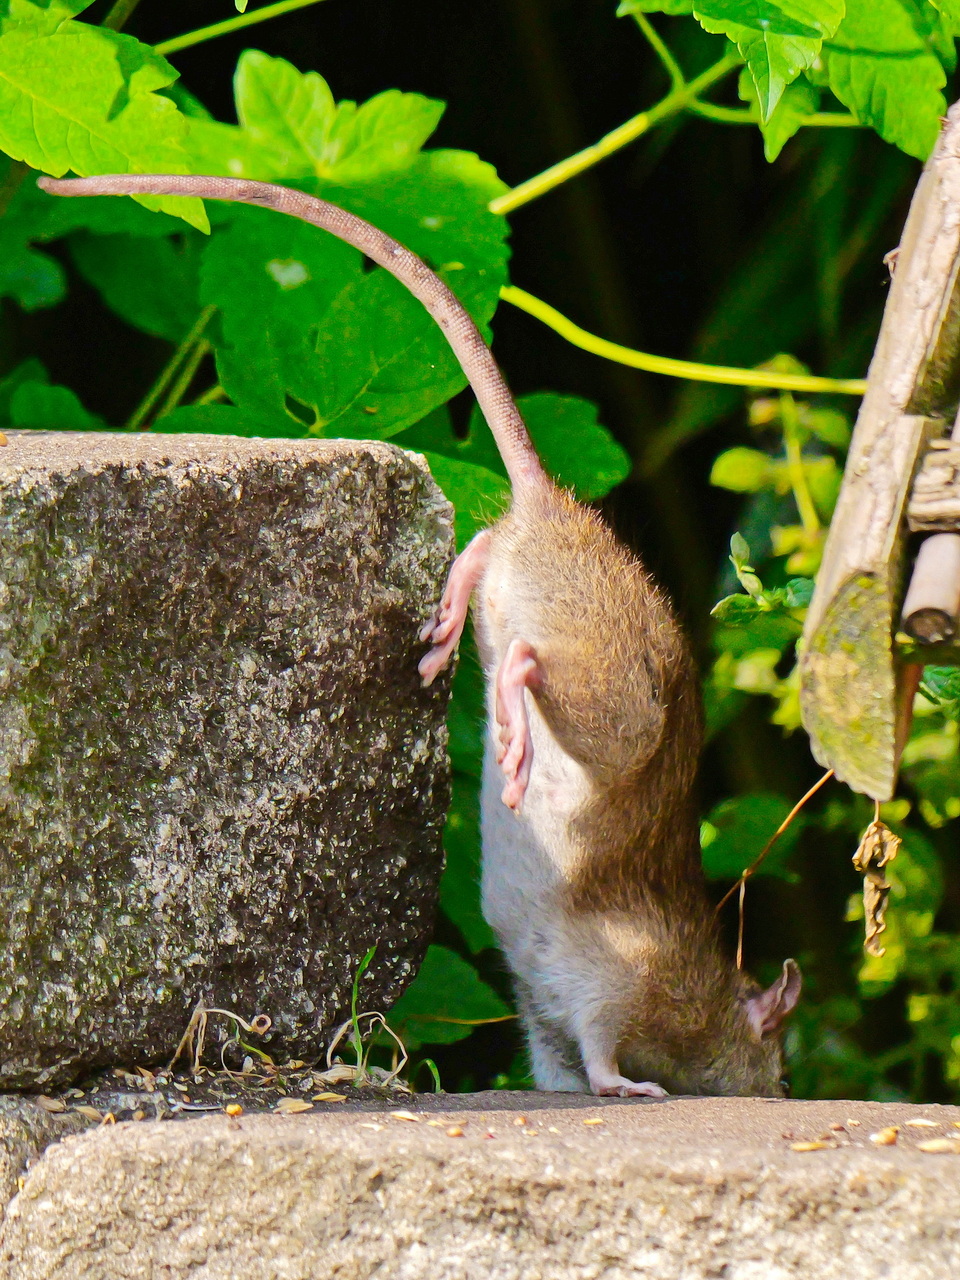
[0,433,452,1089]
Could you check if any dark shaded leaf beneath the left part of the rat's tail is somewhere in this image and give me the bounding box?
[70,232,200,343]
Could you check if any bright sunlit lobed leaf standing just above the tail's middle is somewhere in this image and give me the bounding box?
[236,50,444,183]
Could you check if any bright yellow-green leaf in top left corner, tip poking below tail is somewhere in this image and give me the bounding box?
[0,22,207,230]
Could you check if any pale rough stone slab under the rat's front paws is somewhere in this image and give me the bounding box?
[0,1093,960,1280]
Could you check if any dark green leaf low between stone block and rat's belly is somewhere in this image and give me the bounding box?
[388,946,509,1048]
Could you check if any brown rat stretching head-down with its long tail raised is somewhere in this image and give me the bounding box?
[38,174,800,1097]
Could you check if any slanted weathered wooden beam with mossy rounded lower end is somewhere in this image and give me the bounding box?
[800,105,960,800]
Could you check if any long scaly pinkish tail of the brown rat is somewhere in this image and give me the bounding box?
[37,173,547,498]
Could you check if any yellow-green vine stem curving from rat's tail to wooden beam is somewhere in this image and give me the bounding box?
[500,284,867,396]
